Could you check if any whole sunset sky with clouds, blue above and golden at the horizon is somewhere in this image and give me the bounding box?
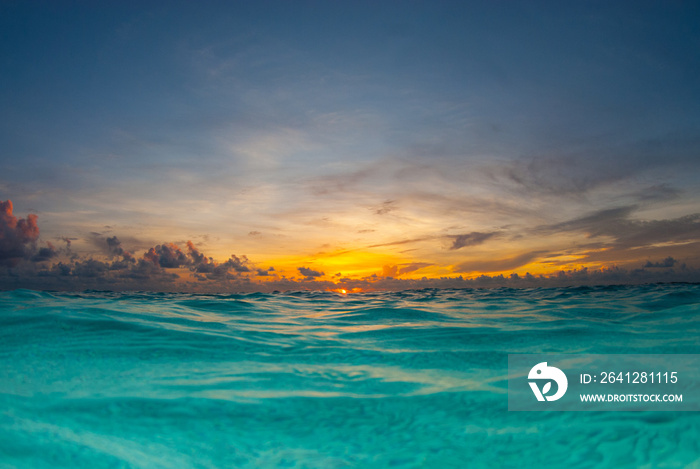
[0,0,700,291]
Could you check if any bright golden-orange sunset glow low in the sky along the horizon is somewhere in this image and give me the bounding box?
[105,233,696,290]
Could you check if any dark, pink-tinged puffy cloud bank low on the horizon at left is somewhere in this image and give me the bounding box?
[0,209,260,290]
